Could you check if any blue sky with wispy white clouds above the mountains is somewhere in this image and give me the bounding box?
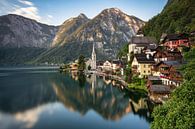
[0,0,167,25]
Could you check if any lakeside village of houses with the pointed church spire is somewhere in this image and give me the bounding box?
[61,31,194,103]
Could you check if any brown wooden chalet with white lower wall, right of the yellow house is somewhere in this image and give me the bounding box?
[152,61,182,86]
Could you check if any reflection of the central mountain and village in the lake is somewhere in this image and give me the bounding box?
[52,74,150,121]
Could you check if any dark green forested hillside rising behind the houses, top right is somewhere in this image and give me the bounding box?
[143,0,195,40]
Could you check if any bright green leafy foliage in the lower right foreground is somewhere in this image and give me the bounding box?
[151,49,195,129]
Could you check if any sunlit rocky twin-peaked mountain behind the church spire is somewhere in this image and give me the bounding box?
[35,8,145,63]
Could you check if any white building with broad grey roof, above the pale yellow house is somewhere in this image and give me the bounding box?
[127,36,156,61]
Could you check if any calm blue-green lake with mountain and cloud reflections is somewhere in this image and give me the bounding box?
[0,67,151,129]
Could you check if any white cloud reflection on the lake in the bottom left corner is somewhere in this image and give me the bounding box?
[0,102,61,129]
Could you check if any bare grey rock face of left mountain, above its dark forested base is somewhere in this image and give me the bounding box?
[0,14,58,48]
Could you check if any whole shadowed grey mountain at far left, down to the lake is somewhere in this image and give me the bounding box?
[0,14,59,65]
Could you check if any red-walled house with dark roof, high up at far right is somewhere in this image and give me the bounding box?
[161,34,190,49]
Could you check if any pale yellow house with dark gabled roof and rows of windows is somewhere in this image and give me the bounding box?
[131,53,155,78]
